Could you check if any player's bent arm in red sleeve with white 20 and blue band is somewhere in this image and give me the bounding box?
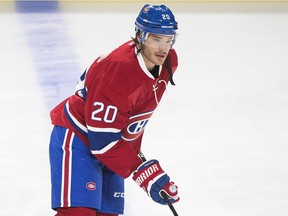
[85,79,142,178]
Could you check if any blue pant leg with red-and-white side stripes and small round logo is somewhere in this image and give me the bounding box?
[50,127,102,209]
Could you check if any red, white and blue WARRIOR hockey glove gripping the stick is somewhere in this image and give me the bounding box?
[133,160,180,205]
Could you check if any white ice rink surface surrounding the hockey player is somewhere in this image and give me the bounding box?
[0,3,288,216]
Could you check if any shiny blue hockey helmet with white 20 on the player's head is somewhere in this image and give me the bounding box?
[135,4,178,36]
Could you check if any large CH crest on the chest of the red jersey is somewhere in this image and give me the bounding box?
[122,111,153,141]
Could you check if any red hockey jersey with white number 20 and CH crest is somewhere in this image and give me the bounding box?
[50,41,178,178]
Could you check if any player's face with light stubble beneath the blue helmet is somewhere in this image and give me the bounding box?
[141,34,173,70]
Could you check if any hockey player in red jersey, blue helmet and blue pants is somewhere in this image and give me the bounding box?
[49,4,179,216]
